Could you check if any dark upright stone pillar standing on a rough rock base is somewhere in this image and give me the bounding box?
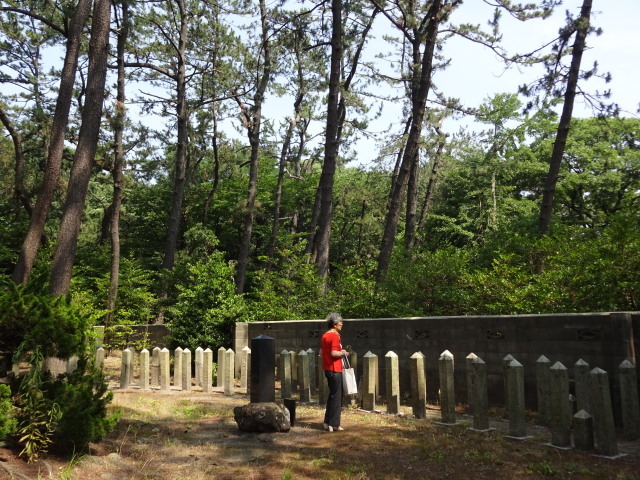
[249,335,276,403]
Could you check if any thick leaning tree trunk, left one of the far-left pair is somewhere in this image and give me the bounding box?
[12,0,92,284]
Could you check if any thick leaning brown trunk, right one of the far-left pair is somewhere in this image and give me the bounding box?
[50,0,111,295]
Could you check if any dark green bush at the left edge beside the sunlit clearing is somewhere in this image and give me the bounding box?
[0,282,116,461]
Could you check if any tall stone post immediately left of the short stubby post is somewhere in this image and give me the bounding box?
[549,362,572,448]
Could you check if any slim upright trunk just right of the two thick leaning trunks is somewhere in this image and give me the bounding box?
[105,0,129,327]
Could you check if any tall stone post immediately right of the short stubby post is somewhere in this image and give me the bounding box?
[589,368,618,457]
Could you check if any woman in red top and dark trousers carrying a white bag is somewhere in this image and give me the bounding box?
[320,312,349,432]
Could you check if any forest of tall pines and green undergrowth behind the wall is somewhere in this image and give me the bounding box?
[0,0,640,351]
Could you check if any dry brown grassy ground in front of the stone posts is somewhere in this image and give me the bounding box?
[0,389,640,480]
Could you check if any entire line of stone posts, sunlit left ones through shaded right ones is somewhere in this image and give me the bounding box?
[102,347,640,456]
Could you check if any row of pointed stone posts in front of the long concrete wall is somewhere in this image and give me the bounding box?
[278,349,640,456]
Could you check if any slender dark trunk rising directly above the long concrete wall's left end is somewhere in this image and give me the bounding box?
[235,0,272,294]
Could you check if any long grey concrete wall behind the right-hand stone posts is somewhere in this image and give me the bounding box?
[234,312,640,408]
